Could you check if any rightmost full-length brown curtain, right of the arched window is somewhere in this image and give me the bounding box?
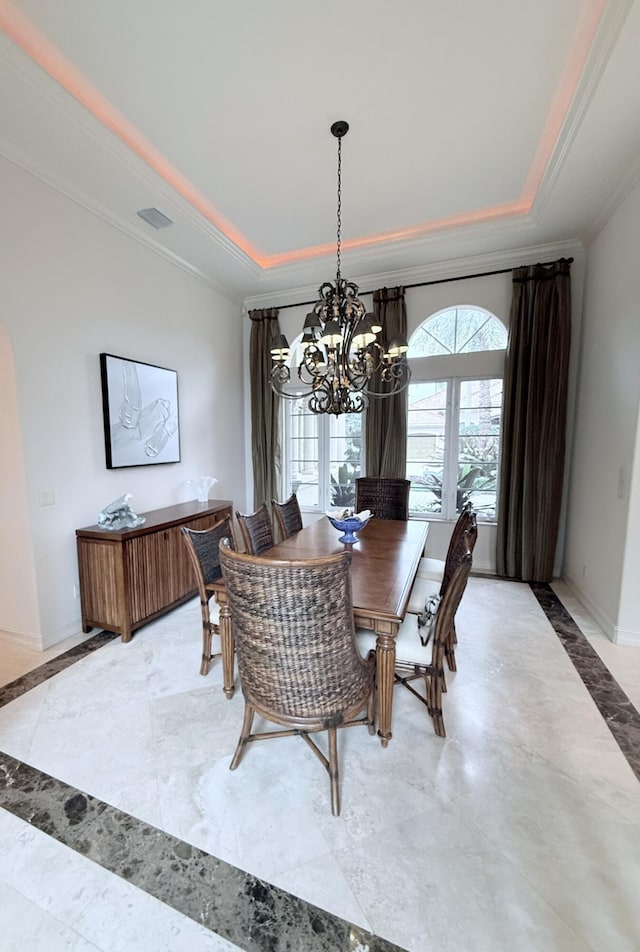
[496,258,571,582]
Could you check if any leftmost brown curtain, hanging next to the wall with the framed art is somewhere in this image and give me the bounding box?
[249,307,281,508]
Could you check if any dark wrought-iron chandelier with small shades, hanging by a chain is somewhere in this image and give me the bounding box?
[271,120,411,416]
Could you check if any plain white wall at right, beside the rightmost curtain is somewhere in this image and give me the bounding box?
[563,175,640,644]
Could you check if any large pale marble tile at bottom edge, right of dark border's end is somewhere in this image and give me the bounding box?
[336,801,590,952]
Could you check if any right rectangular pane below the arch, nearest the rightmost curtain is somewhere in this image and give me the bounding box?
[456,380,502,518]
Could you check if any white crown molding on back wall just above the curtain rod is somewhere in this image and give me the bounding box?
[243,238,585,310]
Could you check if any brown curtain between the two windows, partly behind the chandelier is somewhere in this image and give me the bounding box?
[365,287,407,479]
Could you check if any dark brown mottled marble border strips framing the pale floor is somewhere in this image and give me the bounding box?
[0,583,640,952]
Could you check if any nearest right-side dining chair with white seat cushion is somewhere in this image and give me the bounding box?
[357,536,472,737]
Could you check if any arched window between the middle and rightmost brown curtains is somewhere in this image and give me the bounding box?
[407,306,507,520]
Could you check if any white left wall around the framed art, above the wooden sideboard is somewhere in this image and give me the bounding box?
[0,160,246,647]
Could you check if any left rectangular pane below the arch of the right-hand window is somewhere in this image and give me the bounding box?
[407,380,448,512]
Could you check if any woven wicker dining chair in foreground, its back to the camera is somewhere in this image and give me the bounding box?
[220,543,375,816]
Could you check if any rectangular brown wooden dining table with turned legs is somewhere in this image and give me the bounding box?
[212,518,429,747]
